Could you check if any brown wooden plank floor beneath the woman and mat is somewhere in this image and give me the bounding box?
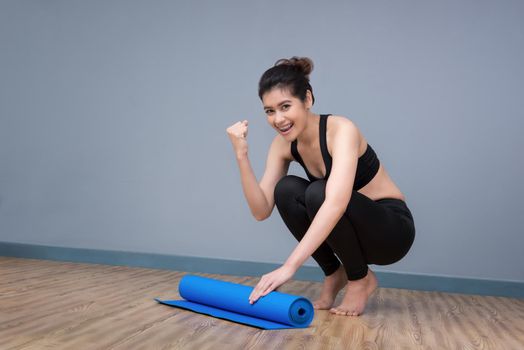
[0,257,524,350]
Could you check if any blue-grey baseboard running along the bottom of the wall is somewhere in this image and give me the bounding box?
[0,242,524,298]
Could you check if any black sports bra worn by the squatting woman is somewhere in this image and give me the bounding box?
[291,114,380,191]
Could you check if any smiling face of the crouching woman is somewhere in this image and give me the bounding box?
[262,88,311,140]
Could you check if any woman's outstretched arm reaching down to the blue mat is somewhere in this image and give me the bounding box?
[249,119,359,304]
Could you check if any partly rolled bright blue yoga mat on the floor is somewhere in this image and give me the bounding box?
[155,275,314,329]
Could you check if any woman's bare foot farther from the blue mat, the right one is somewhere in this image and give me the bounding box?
[329,269,378,316]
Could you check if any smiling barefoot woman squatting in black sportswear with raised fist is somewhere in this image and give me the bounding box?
[227,57,415,316]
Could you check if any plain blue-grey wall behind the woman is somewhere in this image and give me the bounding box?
[0,0,524,281]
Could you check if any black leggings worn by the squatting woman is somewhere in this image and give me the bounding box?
[275,175,415,281]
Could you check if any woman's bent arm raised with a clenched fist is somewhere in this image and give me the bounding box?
[227,120,289,221]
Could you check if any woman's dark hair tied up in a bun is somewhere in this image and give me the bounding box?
[258,56,315,103]
